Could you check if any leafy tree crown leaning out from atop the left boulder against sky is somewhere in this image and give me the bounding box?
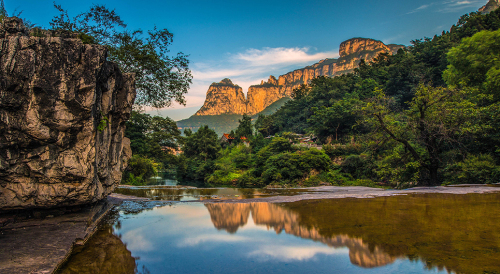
[50,4,192,108]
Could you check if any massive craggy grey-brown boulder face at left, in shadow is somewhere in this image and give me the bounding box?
[0,18,135,210]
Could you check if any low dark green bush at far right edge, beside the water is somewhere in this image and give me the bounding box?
[444,154,500,184]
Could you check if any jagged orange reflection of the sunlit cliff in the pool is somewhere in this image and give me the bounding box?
[205,203,396,268]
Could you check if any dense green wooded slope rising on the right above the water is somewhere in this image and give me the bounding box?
[249,10,500,185]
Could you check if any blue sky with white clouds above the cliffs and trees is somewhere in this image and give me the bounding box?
[8,0,487,120]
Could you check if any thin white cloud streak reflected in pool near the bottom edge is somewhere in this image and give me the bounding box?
[248,245,349,262]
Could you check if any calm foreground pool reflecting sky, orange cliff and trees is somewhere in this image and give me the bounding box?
[56,194,500,273]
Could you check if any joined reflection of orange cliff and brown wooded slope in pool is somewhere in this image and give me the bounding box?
[206,193,500,273]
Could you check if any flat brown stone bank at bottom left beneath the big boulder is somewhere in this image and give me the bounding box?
[0,197,121,274]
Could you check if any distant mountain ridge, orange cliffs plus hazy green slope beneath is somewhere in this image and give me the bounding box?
[177,38,404,135]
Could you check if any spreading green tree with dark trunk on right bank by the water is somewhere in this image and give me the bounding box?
[363,84,477,185]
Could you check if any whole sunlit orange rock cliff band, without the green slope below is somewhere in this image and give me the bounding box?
[195,38,404,115]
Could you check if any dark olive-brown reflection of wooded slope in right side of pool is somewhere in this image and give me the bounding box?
[283,193,500,273]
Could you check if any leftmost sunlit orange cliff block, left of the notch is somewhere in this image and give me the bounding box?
[195,78,247,115]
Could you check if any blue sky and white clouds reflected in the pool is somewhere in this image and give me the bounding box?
[115,203,446,273]
